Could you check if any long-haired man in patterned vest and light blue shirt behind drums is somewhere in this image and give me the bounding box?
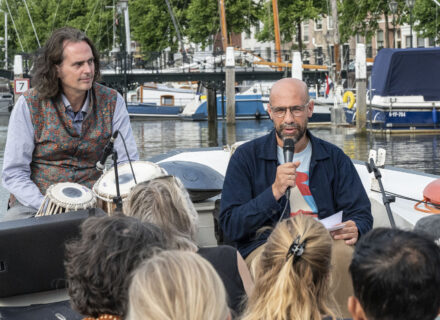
[0,27,138,221]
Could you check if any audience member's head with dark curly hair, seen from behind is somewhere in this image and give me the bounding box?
[65,215,166,317]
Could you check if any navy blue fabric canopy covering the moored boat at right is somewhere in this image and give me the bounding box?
[371,48,440,101]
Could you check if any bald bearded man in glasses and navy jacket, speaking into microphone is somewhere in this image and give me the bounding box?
[219,78,373,265]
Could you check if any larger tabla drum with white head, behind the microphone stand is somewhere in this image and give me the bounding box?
[93,161,167,214]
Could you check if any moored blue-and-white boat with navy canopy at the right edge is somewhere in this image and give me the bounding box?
[344,48,440,133]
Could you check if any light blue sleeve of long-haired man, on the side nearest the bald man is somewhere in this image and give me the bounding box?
[112,93,139,163]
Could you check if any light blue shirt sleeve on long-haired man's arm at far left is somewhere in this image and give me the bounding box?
[2,96,44,209]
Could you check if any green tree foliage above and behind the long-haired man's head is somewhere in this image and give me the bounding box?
[0,0,113,58]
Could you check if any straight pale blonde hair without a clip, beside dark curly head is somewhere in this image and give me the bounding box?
[127,251,229,320]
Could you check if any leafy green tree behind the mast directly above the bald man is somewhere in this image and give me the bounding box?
[257,0,329,52]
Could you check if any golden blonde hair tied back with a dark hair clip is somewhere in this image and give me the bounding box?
[243,215,337,320]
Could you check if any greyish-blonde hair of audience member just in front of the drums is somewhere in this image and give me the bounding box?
[127,176,198,251]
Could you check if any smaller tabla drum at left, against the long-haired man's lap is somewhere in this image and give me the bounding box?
[35,182,96,216]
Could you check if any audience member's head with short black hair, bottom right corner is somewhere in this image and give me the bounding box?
[348,228,440,320]
